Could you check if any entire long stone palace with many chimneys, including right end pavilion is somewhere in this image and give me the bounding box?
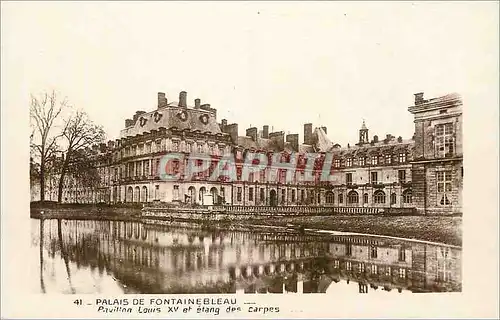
[37,91,463,214]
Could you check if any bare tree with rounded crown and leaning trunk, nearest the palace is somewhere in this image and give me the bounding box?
[57,110,105,203]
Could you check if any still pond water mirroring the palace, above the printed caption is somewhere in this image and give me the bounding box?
[32,220,461,295]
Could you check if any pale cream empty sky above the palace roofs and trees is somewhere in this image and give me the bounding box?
[2,1,498,146]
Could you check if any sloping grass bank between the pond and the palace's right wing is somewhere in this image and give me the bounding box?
[249,216,462,246]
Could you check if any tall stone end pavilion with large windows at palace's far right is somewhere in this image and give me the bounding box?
[408,93,463,214]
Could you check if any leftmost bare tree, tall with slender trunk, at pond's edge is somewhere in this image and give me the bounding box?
[30,91,68,201]
